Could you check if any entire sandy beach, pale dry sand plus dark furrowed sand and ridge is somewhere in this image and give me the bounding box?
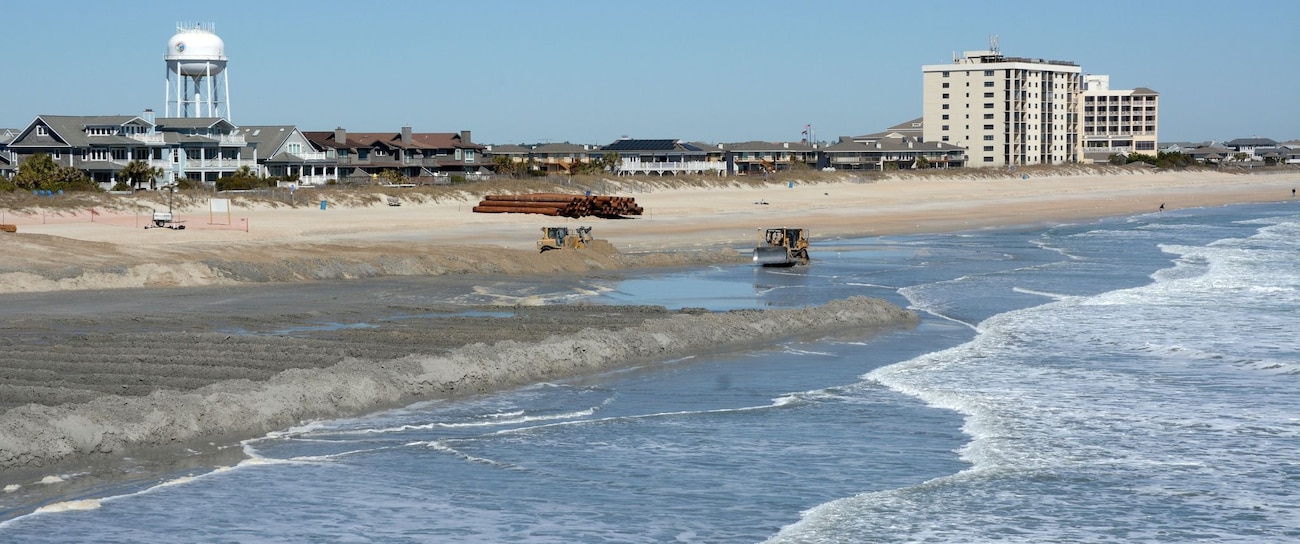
[0,167,1300,487]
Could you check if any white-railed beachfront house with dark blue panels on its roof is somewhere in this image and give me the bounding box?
[599,138,727,176]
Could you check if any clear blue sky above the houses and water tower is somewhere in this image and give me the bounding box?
[0,0,1300,144]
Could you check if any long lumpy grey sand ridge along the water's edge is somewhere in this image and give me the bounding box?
[0,297,918,474]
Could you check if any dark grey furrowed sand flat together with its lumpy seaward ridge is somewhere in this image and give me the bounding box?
[0,298,917,483]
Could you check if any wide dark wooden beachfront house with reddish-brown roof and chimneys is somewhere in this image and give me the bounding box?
[303,126,491,185]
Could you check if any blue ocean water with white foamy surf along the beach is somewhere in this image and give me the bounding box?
[0,202,1300,543]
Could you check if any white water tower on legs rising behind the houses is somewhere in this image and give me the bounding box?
[163,23,230,121]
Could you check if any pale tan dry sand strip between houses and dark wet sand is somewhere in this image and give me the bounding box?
[0,167,1300,294]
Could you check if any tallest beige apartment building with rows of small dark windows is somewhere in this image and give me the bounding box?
[922,48,1080,168]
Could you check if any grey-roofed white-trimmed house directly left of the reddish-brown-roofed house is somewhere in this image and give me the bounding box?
[234,125,338,186]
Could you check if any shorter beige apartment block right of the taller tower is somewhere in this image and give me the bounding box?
[1079,74,1160,163]
